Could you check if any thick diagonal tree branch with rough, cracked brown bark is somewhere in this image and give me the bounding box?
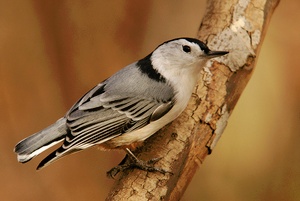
[107,0,279,200]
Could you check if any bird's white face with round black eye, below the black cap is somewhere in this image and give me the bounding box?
[152,39,208,68]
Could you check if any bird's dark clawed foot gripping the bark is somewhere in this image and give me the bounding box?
[106,148,171,178]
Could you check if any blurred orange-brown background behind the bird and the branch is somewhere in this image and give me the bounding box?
[0,0,300,201]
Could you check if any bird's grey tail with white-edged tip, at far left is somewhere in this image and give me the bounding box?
[14,118,68,163]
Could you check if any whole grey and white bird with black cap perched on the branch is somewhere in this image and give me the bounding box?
[14,37,229,175]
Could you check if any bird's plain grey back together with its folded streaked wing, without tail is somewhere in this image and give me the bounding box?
[63,65,174,150]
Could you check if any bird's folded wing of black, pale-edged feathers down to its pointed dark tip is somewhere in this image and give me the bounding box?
[38,82,173,169]
